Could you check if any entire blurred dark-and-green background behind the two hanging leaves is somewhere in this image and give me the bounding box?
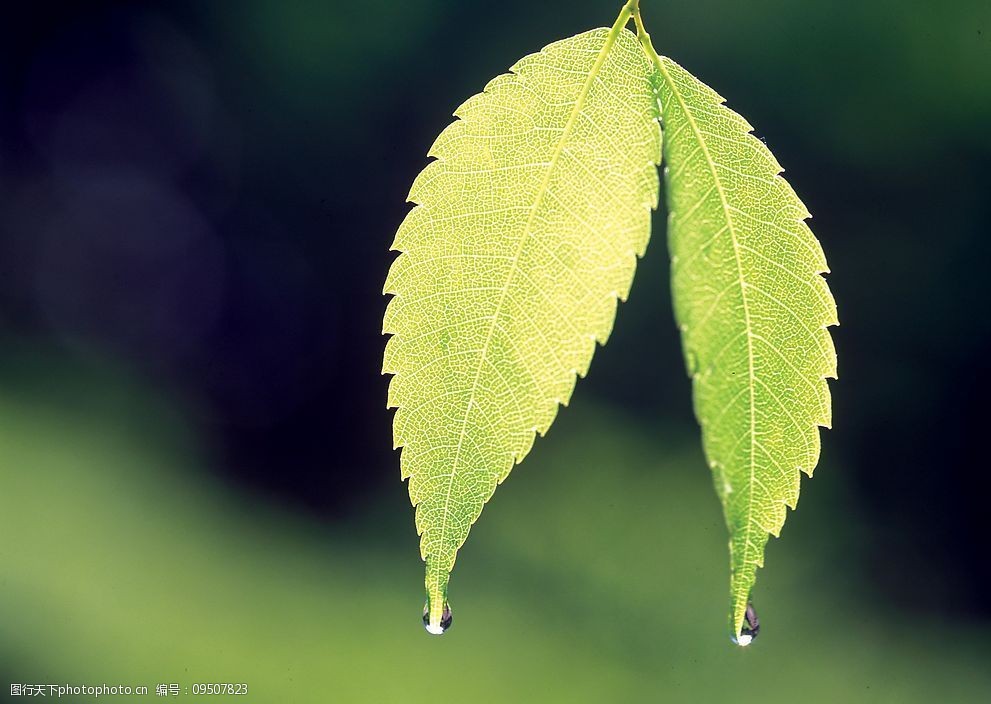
[0,0,991,702]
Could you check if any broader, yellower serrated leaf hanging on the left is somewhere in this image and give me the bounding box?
[383,22,661,632]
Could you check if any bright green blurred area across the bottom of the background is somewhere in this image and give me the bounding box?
[0,360,991,703]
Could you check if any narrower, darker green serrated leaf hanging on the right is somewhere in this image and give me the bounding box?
[656,57,838,644]
